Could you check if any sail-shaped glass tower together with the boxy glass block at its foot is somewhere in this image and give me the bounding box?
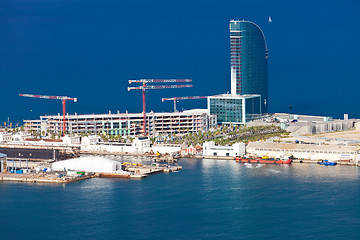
[208,20,268,125]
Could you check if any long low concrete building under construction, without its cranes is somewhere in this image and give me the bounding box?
[24,109,217,136]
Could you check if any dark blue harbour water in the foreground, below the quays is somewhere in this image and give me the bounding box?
[0,159,360,240]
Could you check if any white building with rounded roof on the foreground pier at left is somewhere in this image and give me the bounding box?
[51,156,126,173]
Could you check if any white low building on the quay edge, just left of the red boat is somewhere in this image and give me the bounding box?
[203,141,245,157]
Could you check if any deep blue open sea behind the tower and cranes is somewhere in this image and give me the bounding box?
[0,0,360,123]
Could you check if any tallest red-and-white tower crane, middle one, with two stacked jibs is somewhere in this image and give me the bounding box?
[128,79,192,136]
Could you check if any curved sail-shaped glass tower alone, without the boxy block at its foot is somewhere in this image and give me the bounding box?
[230,20,268,113]
